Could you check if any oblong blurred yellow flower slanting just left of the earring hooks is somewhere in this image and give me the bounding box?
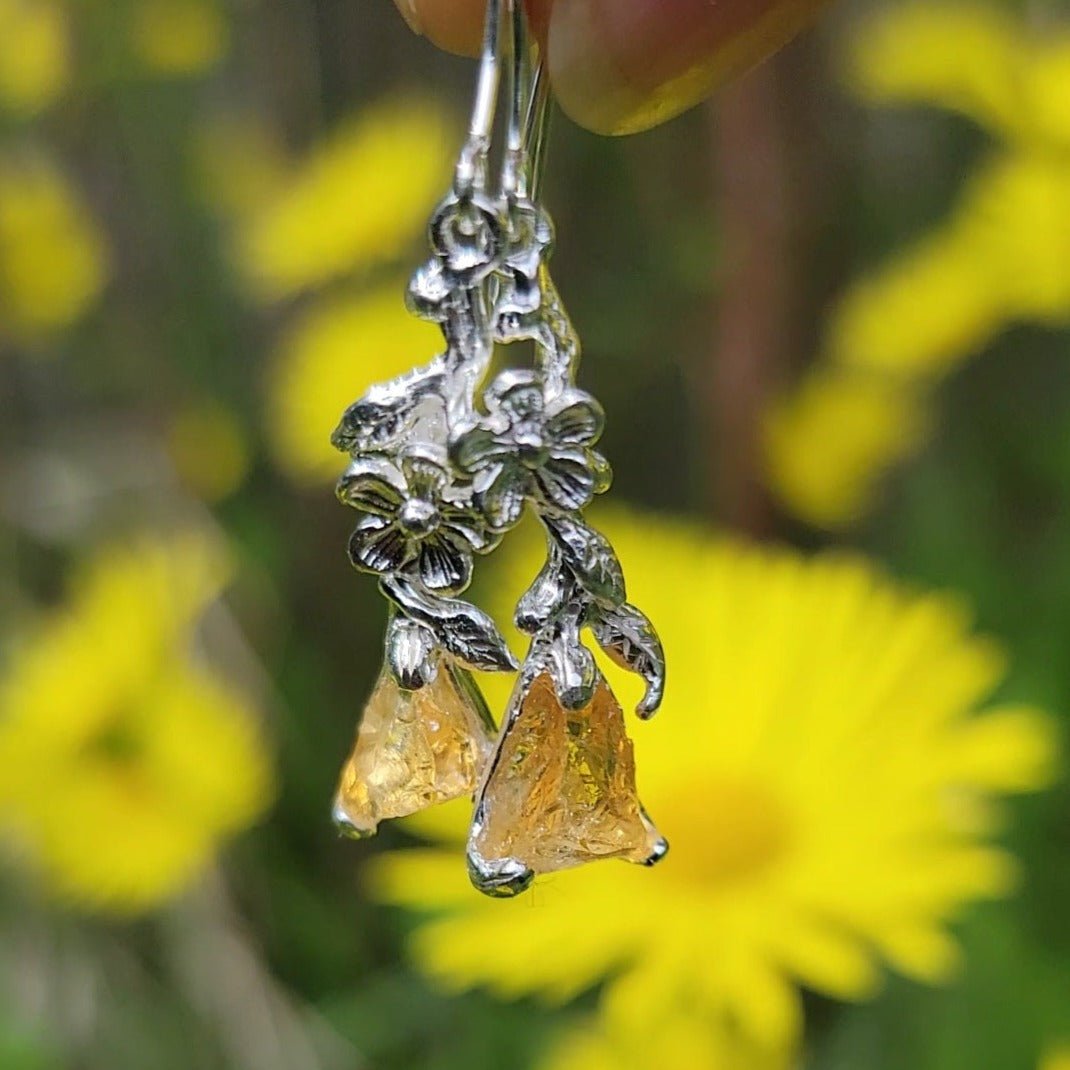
[238,101,456,300]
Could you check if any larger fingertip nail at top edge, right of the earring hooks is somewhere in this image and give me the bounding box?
[548,0,822,134]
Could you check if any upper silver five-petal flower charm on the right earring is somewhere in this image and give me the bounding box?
[453,371,611,531]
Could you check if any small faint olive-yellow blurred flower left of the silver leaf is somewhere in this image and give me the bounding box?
[167,400,250,502]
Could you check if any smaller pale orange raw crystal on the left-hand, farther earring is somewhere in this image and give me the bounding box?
[334,658,494,837]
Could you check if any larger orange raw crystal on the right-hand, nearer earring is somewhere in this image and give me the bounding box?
[469,673,668,896]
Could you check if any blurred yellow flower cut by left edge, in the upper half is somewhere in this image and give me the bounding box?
[0,154,107,340]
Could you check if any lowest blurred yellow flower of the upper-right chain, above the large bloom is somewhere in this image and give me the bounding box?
[762,369,928,531]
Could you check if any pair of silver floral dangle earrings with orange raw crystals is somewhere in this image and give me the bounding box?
[332,0,668,896]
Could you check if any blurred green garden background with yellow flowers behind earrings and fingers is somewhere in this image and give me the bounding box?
[0,0,1070,1070]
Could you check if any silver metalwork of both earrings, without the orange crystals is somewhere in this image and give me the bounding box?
[332,0,666,895]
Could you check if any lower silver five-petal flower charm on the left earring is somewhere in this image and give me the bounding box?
[338,450,498,594]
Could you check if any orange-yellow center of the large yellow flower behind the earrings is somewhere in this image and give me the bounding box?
[656,780,791,887]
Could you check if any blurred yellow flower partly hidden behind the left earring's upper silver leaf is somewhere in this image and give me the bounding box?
[268,281,442,483]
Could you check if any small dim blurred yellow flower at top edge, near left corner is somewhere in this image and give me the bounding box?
[129,0,230,75]
